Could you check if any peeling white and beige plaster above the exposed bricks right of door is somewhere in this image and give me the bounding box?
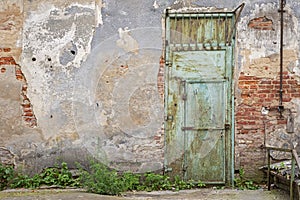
[236,2,299,142]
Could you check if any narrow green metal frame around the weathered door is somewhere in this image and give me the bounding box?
[164,10,236,186]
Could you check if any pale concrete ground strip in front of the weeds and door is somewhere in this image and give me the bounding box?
[0,188,289,200]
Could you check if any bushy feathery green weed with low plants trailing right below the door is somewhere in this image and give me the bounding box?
[80,163,205,195]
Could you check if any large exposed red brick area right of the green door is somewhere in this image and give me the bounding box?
[235,71,300,180]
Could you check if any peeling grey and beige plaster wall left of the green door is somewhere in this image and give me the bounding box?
[1,0,169,173]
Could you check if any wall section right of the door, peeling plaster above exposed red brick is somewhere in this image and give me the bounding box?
[235,1,300,180]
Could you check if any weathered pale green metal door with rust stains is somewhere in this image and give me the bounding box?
[165,10,233,185]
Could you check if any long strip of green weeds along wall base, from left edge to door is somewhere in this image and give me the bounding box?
[0,162,205,195]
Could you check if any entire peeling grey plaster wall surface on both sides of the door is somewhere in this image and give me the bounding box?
[0,0,300,180]
